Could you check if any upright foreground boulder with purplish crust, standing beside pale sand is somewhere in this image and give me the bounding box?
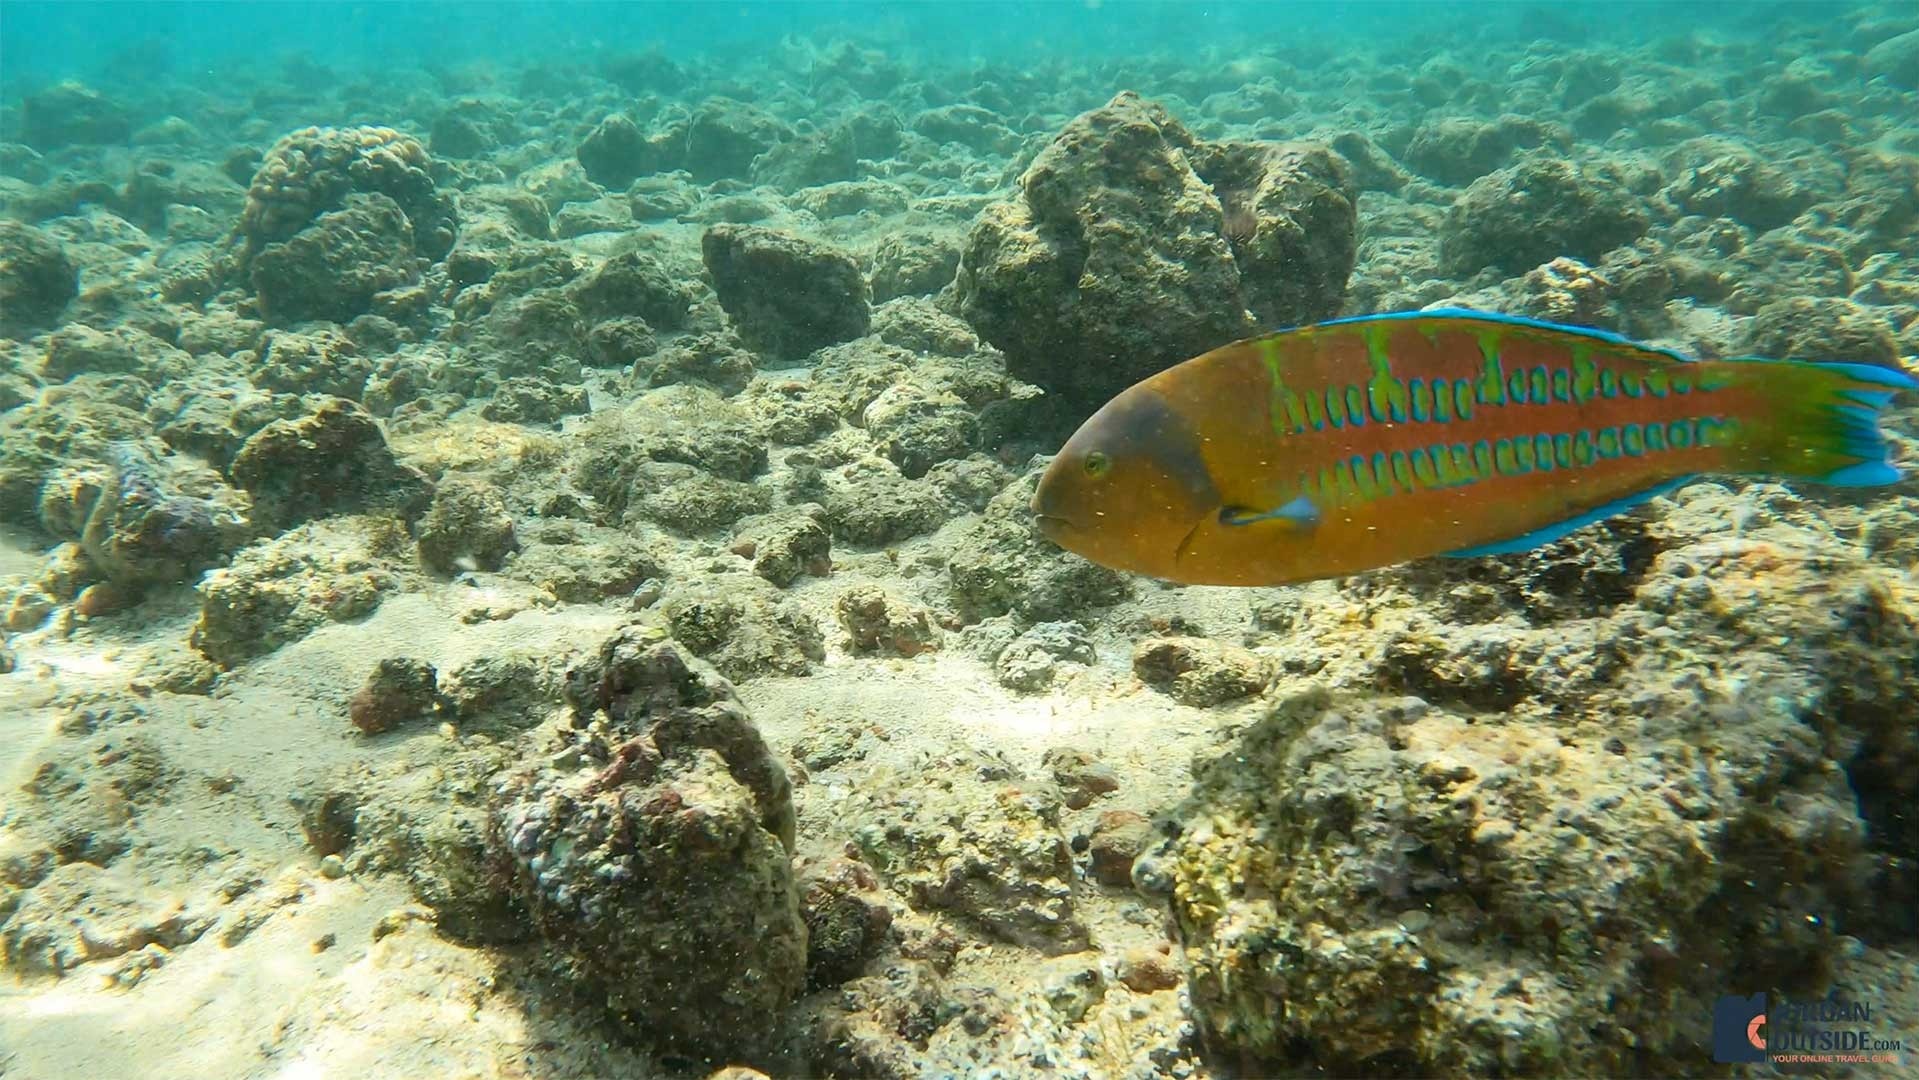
[493,627,806,1057]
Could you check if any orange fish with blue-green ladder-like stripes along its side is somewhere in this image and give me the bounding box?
[1032,309,1919,585]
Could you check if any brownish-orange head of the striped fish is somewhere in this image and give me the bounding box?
[1032,382,1220,579]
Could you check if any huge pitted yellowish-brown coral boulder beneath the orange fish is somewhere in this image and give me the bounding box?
[1132,483,1919,1076]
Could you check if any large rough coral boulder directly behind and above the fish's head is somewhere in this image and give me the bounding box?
[958,92,1357,412]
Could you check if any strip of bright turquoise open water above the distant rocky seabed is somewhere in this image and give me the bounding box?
[0,0,1838,82]
